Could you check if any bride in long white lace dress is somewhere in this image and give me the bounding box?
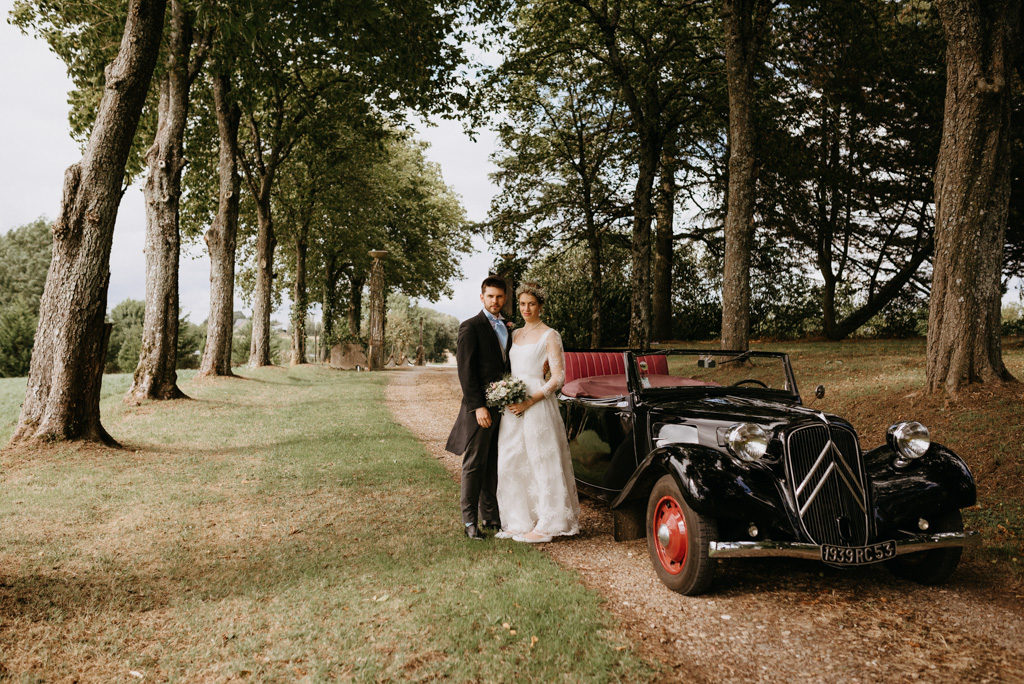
[498,283,580,544]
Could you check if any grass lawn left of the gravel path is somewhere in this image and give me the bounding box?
[0,368,658,682]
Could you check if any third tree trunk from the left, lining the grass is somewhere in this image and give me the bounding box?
[199,71,242,377]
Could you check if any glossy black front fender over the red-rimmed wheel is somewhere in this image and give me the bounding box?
[611,444,788,521]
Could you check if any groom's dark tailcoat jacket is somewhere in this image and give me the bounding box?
[444,311,512,456]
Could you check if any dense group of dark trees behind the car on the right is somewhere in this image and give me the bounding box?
[488,0,1024,391]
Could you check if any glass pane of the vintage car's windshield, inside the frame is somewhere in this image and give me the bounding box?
[630,350,796,393]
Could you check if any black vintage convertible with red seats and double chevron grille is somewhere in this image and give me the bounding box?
[559,350,977,594]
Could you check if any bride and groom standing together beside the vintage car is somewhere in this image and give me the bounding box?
[445,276,580,543]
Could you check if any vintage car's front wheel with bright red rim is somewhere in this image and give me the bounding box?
[646,475,718,596]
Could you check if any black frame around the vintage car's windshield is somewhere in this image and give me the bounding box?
[626,349,803,404]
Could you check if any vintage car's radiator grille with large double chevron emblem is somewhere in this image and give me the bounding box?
[785,425,868,546]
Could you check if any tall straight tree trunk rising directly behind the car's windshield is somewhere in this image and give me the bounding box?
[722,0,757,351]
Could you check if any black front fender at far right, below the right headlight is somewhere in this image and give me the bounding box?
[864,442,978,535]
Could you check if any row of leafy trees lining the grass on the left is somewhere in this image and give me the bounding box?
[12,0,497,442]
